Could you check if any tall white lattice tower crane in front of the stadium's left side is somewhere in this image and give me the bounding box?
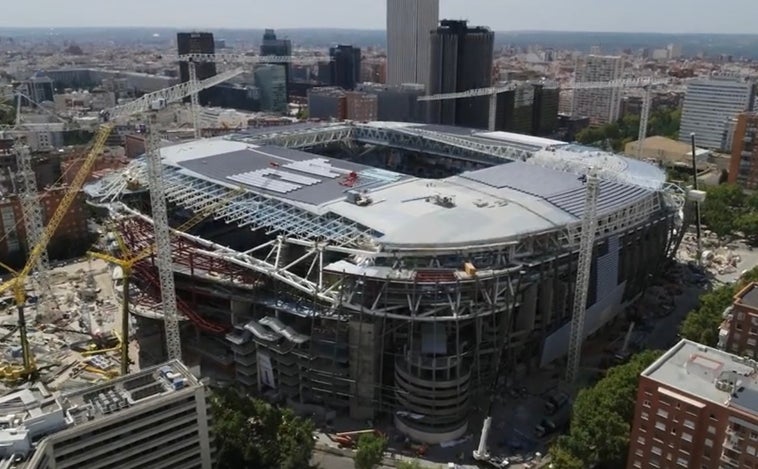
[103,69,243,360]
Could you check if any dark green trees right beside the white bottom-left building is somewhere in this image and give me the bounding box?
[210,391,315,469]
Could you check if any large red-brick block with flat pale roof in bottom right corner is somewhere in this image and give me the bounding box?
[627,340,758,469]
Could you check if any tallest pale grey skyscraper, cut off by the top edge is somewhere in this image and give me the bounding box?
[387,0,440,89]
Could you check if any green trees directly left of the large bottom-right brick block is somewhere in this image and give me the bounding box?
[550,350,660,469]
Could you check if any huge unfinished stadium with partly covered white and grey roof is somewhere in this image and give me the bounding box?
[87,122,684,443]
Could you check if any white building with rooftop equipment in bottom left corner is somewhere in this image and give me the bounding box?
[0,361,212,469]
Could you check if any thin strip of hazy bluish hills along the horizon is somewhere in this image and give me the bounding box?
[0,26,758,36]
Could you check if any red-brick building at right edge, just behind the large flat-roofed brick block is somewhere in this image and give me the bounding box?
[719,282,758,358]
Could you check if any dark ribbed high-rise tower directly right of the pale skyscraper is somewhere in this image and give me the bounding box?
[429,20,495,129]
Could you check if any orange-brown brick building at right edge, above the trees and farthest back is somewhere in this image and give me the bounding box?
[729,112,758,190]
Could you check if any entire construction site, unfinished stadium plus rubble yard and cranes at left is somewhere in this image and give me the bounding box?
[0,63,700,468]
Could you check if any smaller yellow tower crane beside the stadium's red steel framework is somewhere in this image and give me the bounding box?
[87,188,245,375]
